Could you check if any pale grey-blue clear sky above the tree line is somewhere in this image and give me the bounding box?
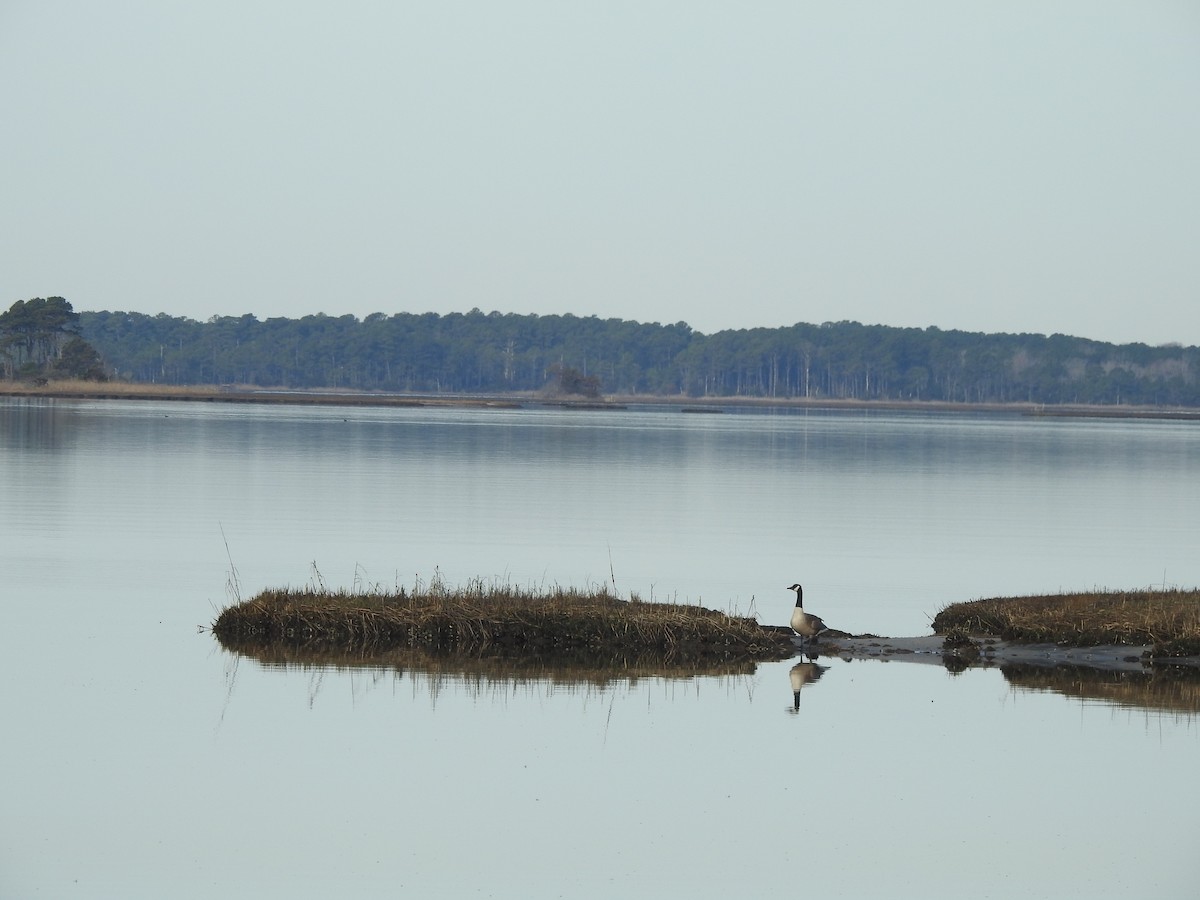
[0,0,1200,344]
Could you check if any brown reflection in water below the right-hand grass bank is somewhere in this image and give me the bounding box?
[1001,665,1200,715]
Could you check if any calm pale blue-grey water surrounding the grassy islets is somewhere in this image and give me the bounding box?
[0,400,1200,900]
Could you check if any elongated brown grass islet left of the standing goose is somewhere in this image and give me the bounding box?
[212,581,793,661]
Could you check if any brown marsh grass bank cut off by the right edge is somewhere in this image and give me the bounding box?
[934,588,1200,656]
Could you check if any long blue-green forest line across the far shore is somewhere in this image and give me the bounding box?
[10,301,1200,406]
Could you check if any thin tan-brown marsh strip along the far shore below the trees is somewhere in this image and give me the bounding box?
[7,380,1200,421]
